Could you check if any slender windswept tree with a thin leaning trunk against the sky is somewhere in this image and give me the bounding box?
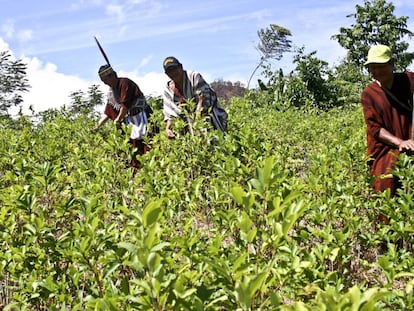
[247,24,292,89]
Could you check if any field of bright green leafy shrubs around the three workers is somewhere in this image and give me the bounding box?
[0,97,414,311]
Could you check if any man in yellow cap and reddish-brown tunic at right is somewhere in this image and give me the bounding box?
[361,45,414,195]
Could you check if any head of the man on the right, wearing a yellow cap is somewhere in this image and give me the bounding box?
[364,44,394,83]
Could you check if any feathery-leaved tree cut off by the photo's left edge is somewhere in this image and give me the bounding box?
[0,51,30,116]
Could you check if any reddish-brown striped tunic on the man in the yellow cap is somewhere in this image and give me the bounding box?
[361,72,414,194]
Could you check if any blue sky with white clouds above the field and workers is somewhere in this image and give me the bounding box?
[0,0,414,111]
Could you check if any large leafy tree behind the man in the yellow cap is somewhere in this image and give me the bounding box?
[332,0,414,69]
